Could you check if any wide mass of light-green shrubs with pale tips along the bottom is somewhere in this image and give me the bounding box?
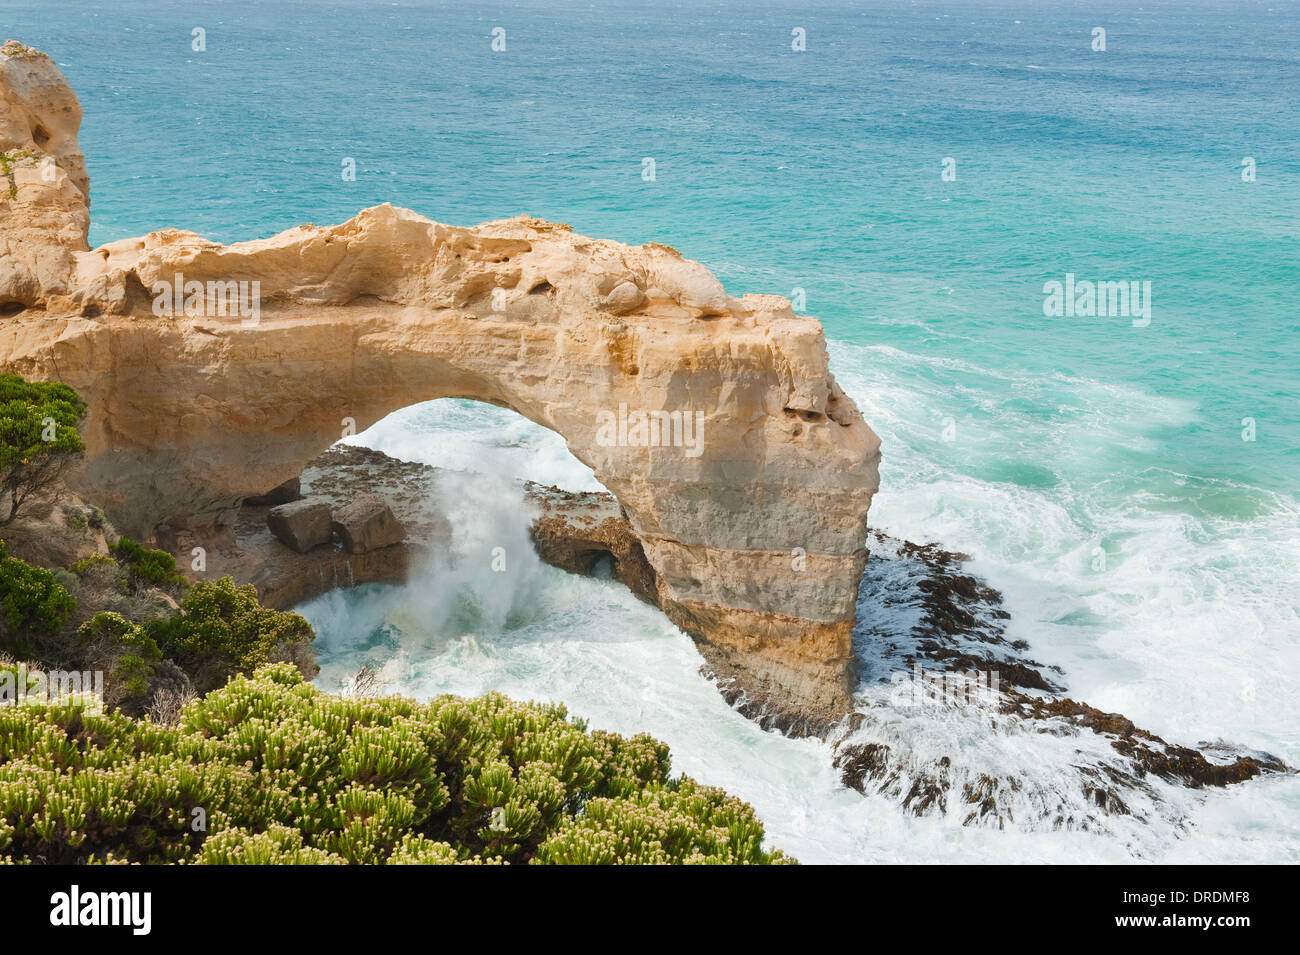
[0,664,789,864]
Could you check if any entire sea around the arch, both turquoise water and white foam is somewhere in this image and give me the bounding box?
[0,0,1300,861]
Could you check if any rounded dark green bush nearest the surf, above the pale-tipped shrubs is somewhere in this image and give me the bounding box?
[147,577,316,693]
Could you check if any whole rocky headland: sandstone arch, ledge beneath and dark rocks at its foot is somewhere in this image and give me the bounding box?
[0,43,1286,828]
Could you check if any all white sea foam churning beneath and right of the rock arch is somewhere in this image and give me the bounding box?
[299,344,1300,863]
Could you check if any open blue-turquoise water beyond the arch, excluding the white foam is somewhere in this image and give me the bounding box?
[17,0,1300,485]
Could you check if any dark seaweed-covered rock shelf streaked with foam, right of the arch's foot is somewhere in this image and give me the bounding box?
[829,533,1291,836]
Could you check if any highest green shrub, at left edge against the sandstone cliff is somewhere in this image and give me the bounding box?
[0,374,86,525]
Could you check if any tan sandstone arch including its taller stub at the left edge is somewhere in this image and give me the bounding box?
[0,45,879,719]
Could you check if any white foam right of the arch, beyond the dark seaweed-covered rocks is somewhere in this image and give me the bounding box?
[836,346,1300,763]
